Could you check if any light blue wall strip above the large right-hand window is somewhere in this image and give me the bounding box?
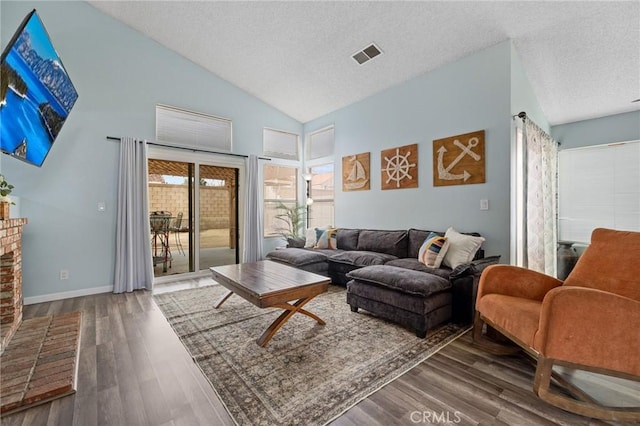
[551,111,640,149]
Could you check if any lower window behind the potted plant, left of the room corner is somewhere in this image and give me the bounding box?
[264,164,298,237]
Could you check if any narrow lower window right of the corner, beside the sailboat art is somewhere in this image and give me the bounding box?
[309,163,334,228]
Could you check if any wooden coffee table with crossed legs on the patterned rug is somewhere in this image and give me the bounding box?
[209,260,331,347]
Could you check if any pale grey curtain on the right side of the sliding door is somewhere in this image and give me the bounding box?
[242,155,263,262]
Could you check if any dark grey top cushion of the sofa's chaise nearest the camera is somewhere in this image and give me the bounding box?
[347,265,451,297]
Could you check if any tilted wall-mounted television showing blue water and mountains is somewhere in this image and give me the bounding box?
[0,9,78,166]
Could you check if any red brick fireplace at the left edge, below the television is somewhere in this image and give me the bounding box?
[0,219,27,353]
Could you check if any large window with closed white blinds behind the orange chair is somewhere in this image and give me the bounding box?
[558,141,640,244]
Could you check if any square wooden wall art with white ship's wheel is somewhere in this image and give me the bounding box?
[380,144,418,189]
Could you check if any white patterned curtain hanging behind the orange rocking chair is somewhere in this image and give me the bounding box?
[524,119,558,277]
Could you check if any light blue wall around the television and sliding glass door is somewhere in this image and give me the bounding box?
[0,0,302,297]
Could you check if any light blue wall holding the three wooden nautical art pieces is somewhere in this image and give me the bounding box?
[304,42,511,262]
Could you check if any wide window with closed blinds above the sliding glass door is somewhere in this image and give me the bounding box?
[156,105,231,152]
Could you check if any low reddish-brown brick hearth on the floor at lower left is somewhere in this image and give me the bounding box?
[0,312,81,416]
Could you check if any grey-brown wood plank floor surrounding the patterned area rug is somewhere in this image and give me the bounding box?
[0,278,640,426]
